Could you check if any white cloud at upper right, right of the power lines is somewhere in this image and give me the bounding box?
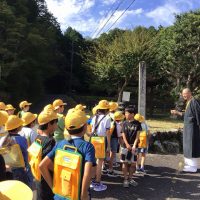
[146,0,193,26]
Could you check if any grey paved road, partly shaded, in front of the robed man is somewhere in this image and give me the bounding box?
[92,154,200,200]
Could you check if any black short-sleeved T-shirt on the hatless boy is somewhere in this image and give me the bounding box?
[122,120,142,147]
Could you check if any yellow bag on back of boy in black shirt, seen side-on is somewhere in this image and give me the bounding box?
[28,139,42,181]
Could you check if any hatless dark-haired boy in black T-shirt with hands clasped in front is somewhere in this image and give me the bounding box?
[121,105,142,187]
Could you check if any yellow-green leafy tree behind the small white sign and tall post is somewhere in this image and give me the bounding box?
[86,27,156,101]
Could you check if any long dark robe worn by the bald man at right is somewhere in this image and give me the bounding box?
[183,98,200,158]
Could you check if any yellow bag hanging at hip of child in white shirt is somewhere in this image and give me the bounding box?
[90,136,106,159]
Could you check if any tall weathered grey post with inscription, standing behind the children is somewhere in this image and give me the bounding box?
[138,61,146,118]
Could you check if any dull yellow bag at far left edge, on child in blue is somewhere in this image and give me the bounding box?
[0,144,25,168]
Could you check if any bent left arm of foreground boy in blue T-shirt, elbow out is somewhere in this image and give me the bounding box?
[39,156,53,188]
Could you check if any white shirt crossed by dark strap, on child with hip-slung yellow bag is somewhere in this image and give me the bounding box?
[91,115,111,136]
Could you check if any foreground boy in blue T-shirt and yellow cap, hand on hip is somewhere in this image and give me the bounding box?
[40,109,96,200]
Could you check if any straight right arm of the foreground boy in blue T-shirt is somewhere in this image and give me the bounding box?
[81,162,92,200]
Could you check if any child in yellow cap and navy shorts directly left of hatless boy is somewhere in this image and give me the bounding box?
[107,111,125,177]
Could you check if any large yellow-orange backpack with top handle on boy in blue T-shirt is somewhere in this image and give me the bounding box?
[53,145,82,200]
